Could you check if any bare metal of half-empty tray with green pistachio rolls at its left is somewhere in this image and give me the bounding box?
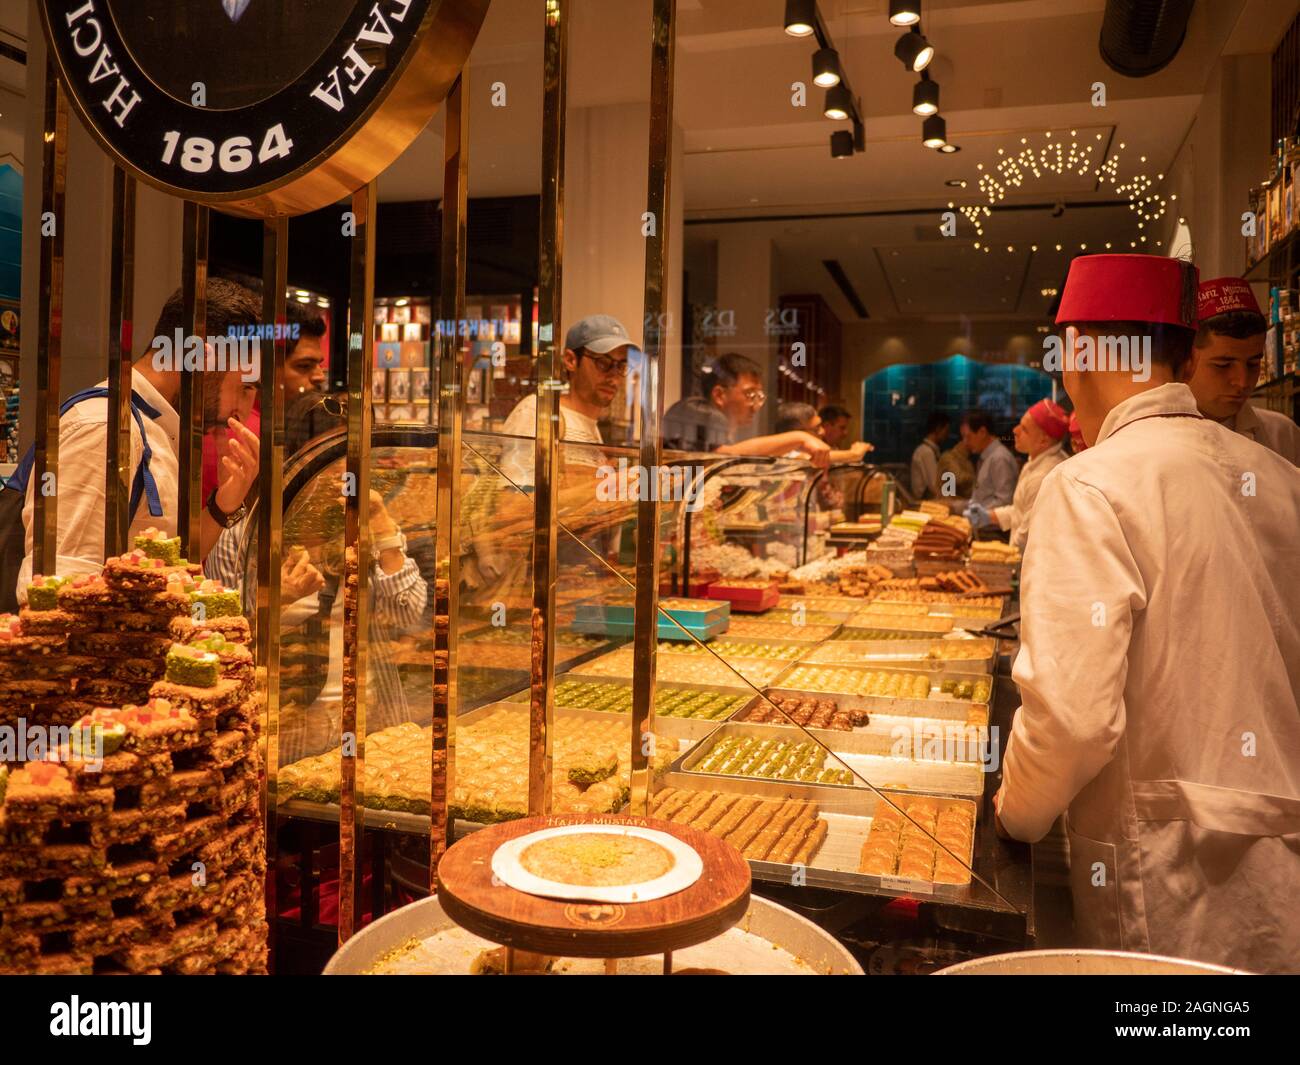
[670,720,984,798]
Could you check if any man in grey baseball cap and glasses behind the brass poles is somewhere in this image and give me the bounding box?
[501,315,633,485]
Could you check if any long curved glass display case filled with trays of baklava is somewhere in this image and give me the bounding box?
[246,427,1031,957]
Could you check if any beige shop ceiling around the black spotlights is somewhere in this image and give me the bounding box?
[380,0,1300,321]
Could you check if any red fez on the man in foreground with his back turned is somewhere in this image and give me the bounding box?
[1057,255,1199,329]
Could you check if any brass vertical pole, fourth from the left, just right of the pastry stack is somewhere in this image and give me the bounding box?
[253,218,289,958]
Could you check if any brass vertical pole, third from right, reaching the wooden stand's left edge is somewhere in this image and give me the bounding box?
[429,65,469,891]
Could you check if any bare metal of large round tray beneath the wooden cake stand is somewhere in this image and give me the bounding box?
[325,895,862,977]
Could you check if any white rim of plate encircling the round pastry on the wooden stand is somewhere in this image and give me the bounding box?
[491,823,705,902]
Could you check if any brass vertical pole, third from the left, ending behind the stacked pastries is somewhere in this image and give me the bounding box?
[176,200,208,562]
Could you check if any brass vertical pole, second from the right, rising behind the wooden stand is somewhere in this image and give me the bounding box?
[528,0,568,815]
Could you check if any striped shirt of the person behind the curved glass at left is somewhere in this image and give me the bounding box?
[203,519,429,765]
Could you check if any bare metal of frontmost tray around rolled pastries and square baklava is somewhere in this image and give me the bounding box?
[663,769,977,909]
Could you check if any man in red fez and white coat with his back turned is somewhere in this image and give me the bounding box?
[996,255,1300,971]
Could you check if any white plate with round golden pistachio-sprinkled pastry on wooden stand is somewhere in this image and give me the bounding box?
[491,823,705,902]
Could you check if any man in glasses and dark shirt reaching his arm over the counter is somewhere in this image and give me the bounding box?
[663,352,831,468]
